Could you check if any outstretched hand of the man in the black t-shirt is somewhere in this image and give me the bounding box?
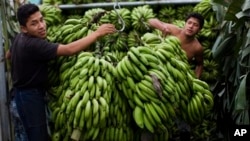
[95,24,117,37]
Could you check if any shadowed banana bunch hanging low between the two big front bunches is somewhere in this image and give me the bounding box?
[97,86,134,141]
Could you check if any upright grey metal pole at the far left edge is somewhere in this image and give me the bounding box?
[0,2,11,141]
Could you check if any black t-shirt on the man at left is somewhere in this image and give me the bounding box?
[10,33,58,88]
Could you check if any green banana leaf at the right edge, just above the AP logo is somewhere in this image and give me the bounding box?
[233,72,250,124]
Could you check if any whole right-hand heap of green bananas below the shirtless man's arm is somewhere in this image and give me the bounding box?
[115,33,213,136]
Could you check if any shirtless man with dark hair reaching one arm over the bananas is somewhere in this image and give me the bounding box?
[148,13,204,78]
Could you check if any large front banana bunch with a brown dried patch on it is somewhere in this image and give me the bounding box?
[115,46,185,133]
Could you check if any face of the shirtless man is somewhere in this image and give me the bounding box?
[184,17,200,36]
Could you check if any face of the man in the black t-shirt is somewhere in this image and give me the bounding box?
[21,11,47,39]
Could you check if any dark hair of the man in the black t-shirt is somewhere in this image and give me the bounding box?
[17,3,39,26]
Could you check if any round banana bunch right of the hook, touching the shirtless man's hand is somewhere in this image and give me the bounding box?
[131,5,155,33]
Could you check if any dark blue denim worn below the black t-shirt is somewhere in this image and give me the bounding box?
[14,89,49,141]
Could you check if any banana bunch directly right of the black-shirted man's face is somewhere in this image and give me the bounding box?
[39,4,62,26]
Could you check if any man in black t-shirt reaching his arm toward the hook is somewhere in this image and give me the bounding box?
[6,4,116,141]
